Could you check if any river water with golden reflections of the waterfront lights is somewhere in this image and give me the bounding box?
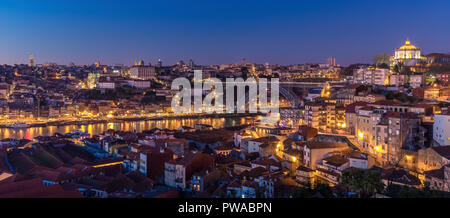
[0,117,255,139]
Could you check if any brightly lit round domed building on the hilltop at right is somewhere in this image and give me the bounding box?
[391,40,426,67]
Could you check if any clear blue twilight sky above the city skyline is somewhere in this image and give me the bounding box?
[0,0,450,65]
